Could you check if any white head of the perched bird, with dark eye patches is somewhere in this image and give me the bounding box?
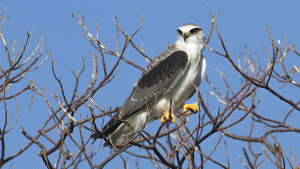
[177,23,205,44]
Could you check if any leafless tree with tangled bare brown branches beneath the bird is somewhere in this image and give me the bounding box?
[0,9,300,169]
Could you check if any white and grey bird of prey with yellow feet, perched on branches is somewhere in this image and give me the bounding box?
[92,23,206,146]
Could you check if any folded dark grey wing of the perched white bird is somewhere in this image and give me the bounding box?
[103,47,189,136]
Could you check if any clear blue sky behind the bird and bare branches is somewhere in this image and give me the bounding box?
[0,0,300,168]
